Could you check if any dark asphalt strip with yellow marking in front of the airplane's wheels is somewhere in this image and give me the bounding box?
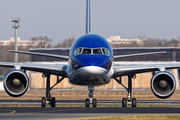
[0,107,180,120]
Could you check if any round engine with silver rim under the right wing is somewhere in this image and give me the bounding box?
[151,71,176,99]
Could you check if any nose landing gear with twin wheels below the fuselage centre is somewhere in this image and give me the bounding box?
[85,85,97,107]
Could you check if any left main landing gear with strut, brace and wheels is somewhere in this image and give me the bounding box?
[41,74,65,107]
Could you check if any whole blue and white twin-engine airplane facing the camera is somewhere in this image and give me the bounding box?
[0,0,180,107]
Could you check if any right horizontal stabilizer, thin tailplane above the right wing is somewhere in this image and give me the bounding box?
[114,51,166,59]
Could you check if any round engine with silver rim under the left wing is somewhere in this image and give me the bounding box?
[4,70,29,97]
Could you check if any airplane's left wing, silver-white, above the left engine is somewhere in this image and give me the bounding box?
[0,62,68,77]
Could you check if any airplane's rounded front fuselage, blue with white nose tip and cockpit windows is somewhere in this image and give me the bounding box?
[67,34,113,85]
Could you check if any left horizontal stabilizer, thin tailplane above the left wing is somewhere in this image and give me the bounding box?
[9,50,69,60]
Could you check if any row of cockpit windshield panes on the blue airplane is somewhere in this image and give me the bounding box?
[74,48,110,56]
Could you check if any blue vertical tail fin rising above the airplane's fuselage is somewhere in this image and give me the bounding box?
[86,0,91,34]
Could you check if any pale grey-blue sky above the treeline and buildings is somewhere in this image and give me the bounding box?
[0,0,180,44]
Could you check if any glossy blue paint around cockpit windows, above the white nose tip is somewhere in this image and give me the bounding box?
[70,34,113,71]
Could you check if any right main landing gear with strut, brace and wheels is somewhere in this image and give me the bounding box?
[114,75,136,107]
